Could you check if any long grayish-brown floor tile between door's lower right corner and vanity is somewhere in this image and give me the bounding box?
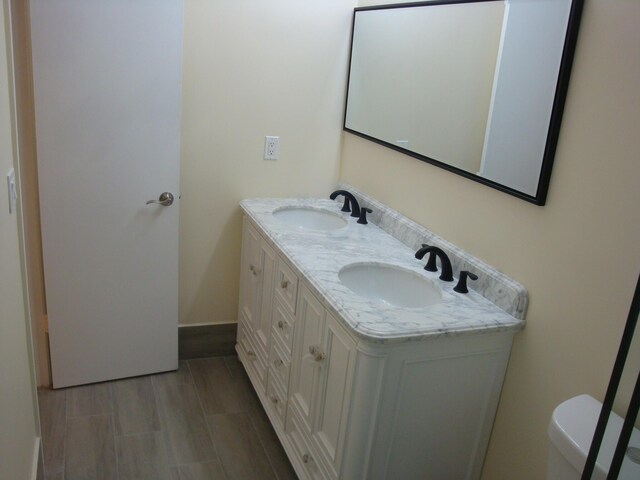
[156,384,217,465]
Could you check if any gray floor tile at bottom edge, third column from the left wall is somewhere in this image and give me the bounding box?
[116,432,172,480]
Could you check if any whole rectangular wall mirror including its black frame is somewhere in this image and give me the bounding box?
[344,0,583,205]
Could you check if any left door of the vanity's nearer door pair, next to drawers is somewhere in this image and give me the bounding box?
[290,287,324,434]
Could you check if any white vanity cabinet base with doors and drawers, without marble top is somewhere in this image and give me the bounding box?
[236,217,514,480]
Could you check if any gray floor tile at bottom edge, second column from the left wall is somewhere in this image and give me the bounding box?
[64,415,118,480]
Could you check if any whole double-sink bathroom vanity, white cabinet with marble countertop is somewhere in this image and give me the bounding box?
[236,186,527,480]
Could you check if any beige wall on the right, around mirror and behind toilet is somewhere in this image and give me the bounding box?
[340,0,640,480]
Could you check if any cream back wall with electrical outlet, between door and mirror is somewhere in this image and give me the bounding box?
[180,0,355,324]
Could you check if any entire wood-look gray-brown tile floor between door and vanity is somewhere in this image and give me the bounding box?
[38,356,297,480]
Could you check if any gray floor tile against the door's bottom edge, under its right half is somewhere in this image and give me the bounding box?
[111,377,160,435]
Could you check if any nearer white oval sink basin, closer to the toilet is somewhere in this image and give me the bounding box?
[338,263,442,308]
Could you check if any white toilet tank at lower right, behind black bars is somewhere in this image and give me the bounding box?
[547,395,640,480]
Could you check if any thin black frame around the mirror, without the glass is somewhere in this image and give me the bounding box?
[342,0,584,206]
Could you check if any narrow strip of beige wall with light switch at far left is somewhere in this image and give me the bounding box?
[0,0,39,479]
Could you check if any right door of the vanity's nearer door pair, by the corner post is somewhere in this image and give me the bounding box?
[313,313,355,472]
